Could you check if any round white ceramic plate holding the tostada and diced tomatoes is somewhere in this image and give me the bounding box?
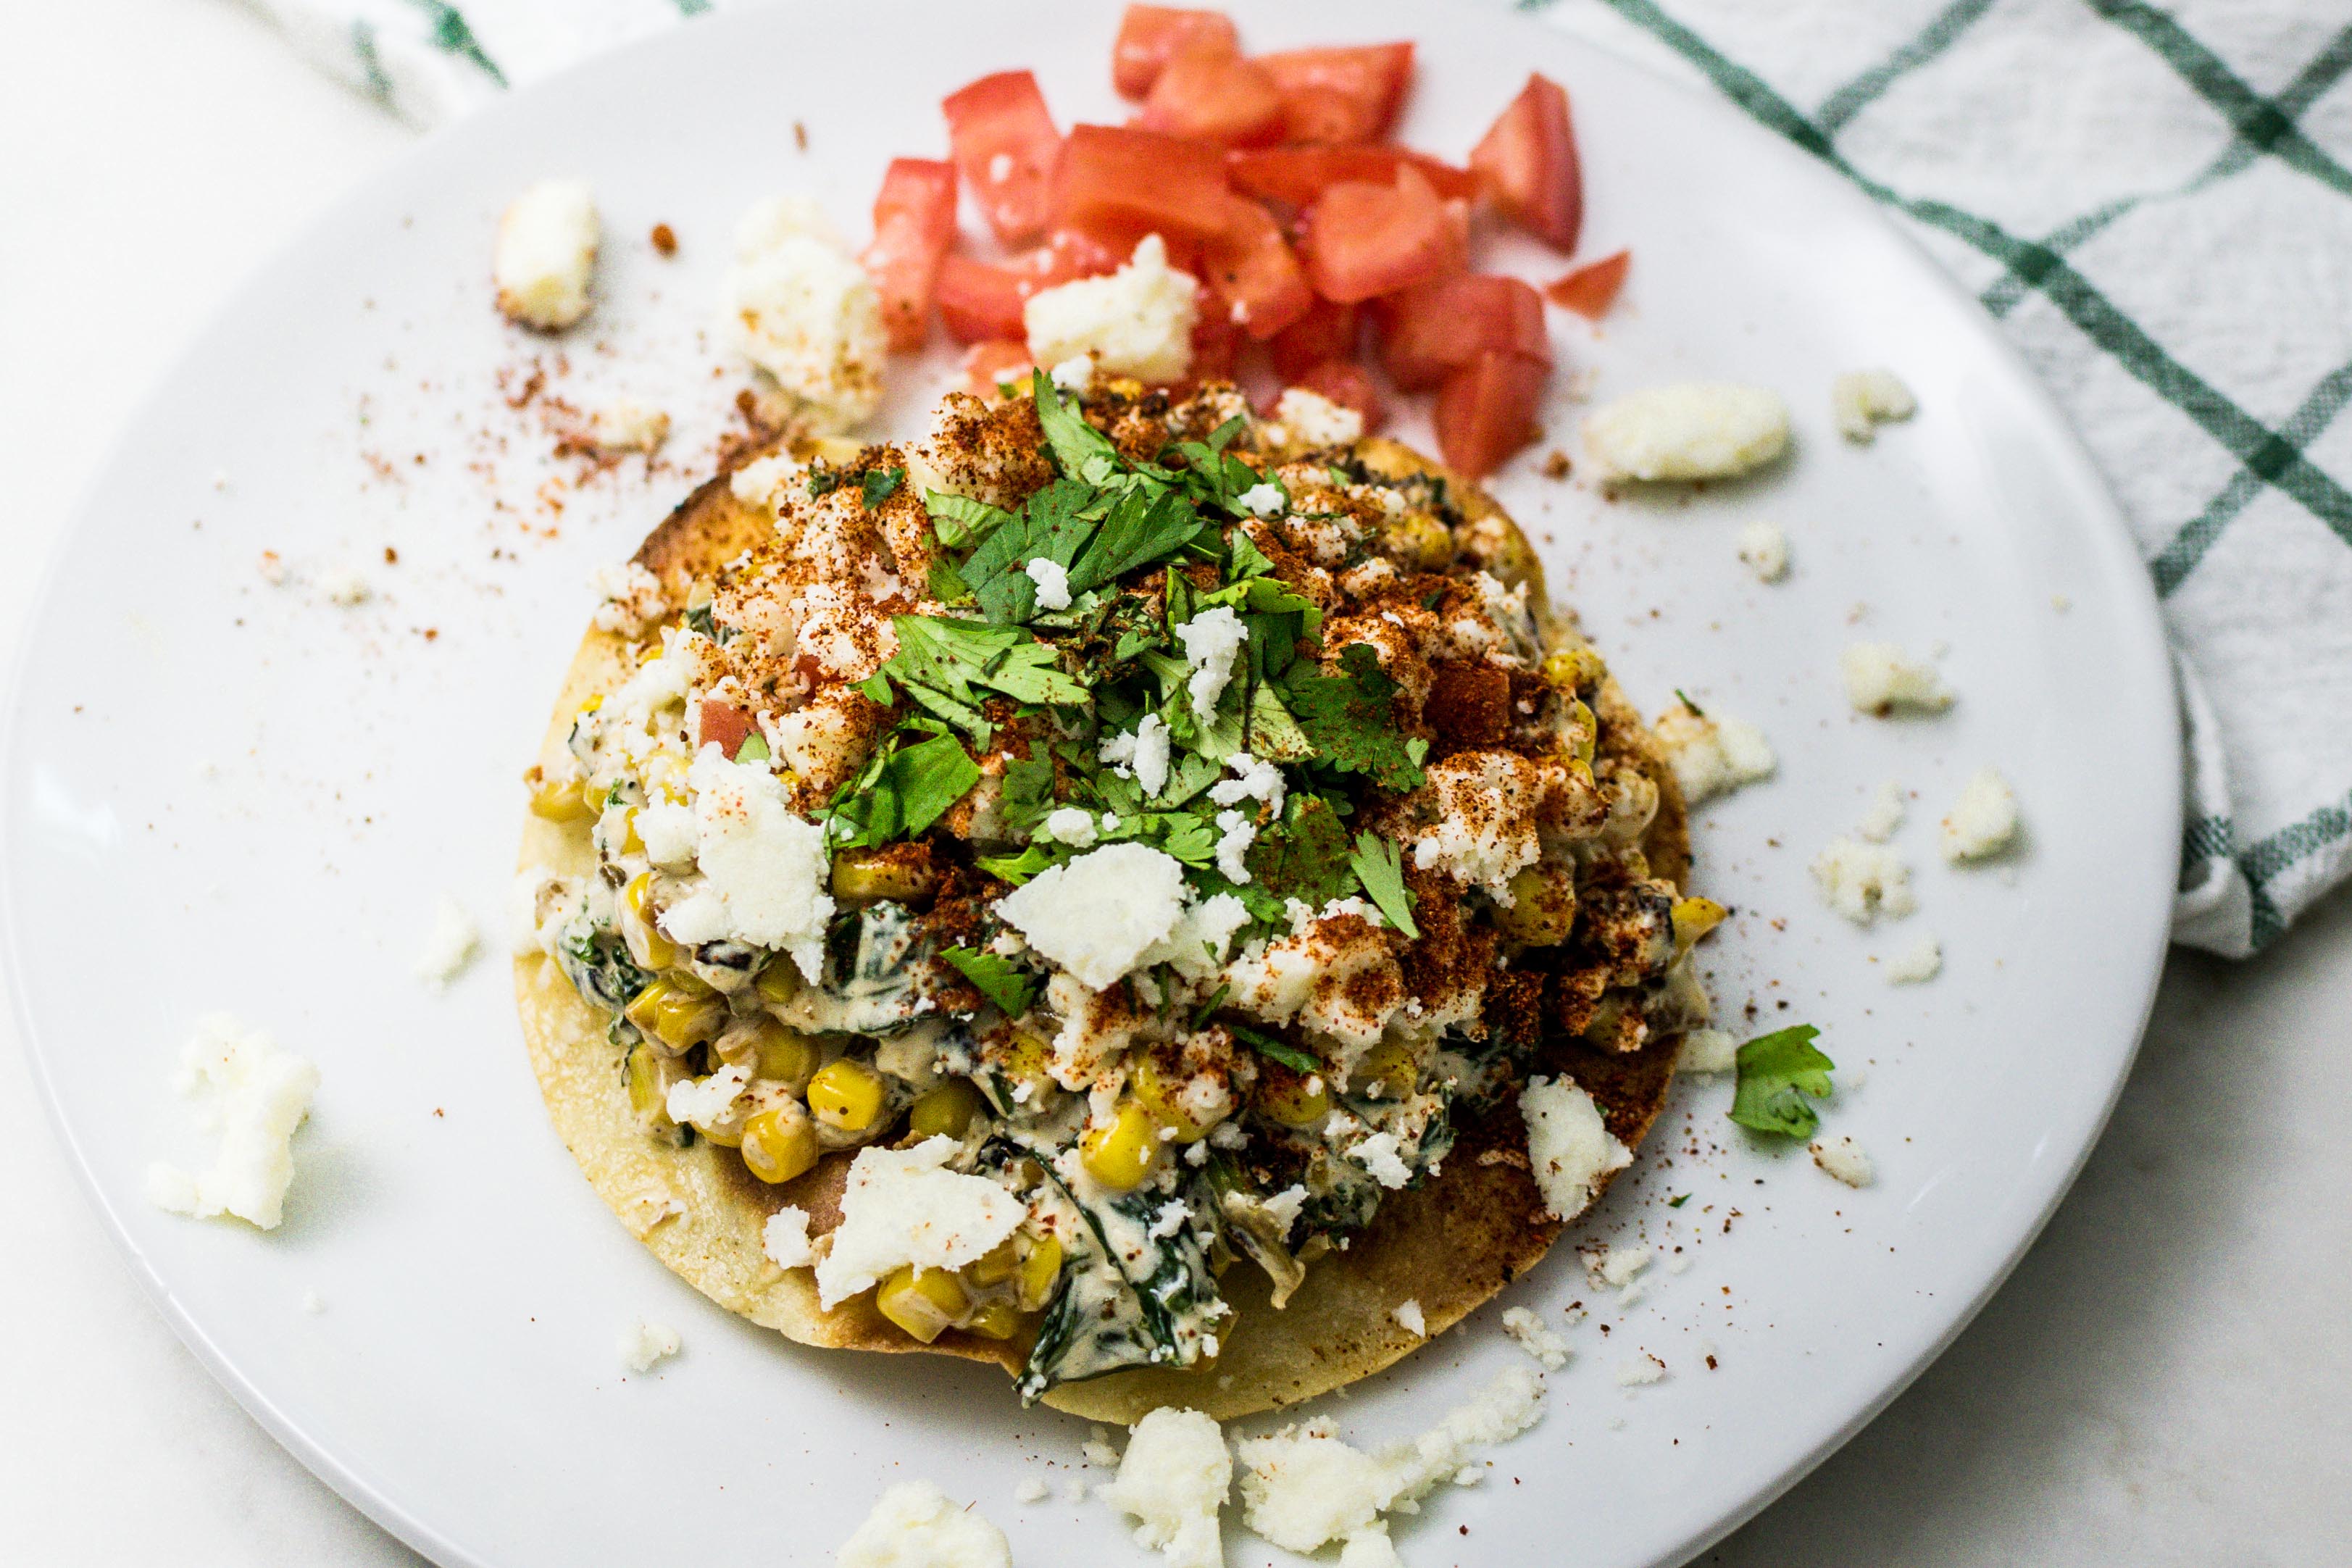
[4,2,2178,1568]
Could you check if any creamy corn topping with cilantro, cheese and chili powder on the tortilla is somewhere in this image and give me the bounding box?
[532,376,1722,1396]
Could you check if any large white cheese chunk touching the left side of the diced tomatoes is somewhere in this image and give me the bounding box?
[727,198,889,435]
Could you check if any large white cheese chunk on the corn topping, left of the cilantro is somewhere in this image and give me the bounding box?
[656,747,833,980]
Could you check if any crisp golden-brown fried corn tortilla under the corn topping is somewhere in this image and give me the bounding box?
[515,425,1689,1422]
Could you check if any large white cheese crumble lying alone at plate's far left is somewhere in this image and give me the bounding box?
[148,1013,317,1230]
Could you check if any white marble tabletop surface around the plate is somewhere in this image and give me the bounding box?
[0,0,2352,1568]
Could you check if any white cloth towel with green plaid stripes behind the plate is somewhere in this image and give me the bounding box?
[264,0,2352,954]
